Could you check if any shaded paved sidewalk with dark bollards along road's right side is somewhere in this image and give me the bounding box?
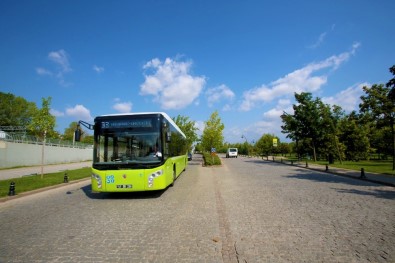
[263,159,395,187]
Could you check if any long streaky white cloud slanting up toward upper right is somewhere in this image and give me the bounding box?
[240,43,360,111]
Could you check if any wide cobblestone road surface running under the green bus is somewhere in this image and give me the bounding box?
[0,157,395,262]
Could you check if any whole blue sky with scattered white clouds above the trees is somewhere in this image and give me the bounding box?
[0,0,395,143]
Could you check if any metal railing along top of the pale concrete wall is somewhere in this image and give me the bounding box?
[0,132,93,149]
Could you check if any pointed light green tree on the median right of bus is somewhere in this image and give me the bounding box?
[202,111,225,151]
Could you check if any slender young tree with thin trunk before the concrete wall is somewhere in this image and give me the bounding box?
[29,97,56,178]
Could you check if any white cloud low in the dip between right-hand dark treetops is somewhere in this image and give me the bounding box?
[322,83,370,112]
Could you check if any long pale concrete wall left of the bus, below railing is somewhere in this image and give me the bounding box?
[0,140,93,168]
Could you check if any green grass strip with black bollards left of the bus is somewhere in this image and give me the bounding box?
[0,167,91,197]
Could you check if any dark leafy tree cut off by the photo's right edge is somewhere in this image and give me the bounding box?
[359,81,395,170]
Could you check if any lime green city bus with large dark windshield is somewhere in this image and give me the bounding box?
[92,112,188,192]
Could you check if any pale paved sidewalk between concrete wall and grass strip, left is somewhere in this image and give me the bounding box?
[0,161,92,180]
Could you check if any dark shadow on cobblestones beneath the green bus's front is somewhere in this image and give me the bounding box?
[81,185,167,199]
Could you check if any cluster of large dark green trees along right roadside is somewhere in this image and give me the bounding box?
[281,66,395,169]
